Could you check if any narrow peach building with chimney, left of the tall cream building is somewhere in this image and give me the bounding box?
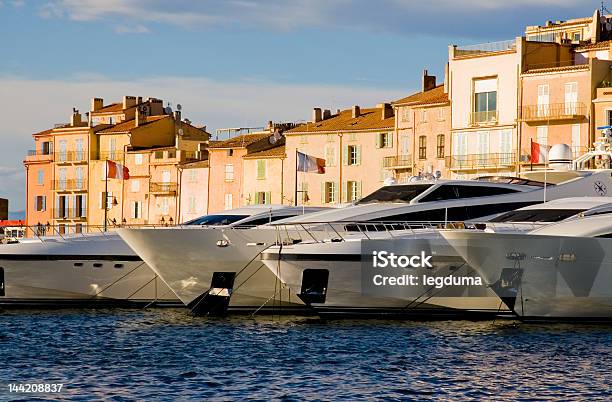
[392,70,451,181]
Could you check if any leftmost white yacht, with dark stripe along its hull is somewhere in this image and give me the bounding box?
[0,207,304,307]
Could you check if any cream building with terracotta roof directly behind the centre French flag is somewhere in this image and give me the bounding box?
[284,103,397,205]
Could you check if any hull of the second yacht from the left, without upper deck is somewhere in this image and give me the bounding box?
[119,228,306,314]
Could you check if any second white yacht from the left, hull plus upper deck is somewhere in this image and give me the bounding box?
[118,205,327,315]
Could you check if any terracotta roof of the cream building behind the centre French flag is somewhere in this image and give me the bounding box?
[285,108,395,135]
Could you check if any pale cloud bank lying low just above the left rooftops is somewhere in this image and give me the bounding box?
[0,74,412,210]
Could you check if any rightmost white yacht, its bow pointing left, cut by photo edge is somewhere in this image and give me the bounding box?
[441,206,612,320]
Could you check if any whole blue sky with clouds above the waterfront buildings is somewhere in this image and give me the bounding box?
[0,0,612,211]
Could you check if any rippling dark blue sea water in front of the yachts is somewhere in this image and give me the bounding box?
[0,309,612,401]
